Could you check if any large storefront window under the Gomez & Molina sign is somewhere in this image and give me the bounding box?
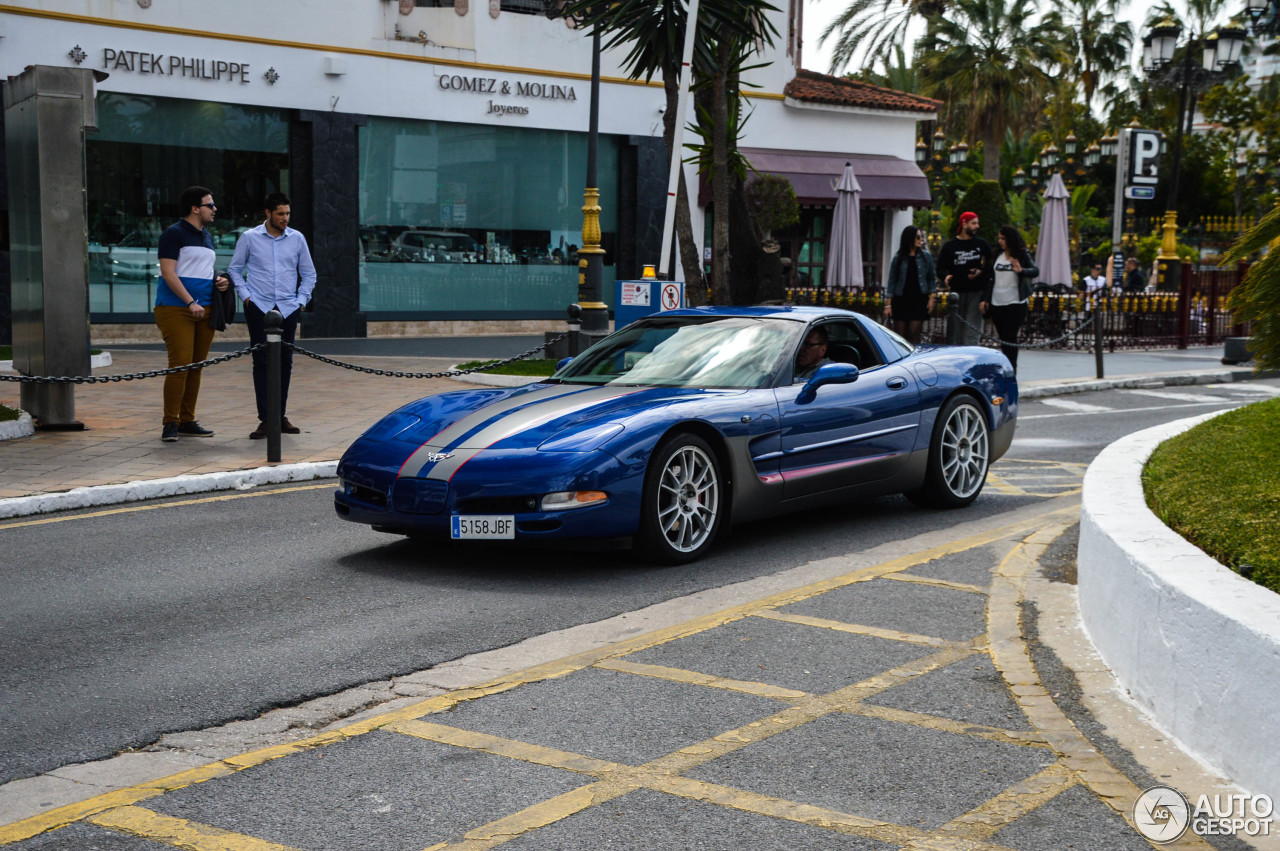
[360,118,618,319]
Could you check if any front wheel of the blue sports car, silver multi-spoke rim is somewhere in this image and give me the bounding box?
[635,434,727,564]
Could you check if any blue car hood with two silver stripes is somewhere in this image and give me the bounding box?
[381,384,744,476]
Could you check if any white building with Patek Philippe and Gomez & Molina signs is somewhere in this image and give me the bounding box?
[0,0,937,337]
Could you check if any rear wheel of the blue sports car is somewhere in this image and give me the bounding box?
[908,395,991,508]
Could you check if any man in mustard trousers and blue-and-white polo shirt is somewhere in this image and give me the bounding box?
[155,186,230,443]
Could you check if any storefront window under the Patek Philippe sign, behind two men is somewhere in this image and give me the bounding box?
[86,92,289,321]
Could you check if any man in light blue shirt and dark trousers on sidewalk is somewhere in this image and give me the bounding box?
[228,192,316,440]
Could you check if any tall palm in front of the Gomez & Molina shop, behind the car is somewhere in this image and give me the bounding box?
[561,0,777,303]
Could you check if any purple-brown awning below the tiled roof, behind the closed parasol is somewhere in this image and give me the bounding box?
[698,147,929,207]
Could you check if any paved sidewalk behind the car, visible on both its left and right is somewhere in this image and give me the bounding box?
[0,337,1249,518]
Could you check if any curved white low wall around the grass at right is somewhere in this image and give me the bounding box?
[1079,413,1280,800]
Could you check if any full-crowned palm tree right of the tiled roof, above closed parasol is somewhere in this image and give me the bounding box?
[920,0,1070,180]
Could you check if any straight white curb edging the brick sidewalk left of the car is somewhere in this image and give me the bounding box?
[0,461,338,520]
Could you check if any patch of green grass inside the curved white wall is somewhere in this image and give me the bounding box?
[1142,399,1280,594]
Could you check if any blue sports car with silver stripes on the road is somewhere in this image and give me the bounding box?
[334,307,1018,563]
